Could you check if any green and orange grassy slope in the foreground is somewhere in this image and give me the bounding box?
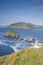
[0,47,43,65]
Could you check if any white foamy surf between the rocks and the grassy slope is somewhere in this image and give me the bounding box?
[0,38,41,52]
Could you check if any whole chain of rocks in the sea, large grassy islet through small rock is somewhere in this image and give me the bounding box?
[4,30,36,43]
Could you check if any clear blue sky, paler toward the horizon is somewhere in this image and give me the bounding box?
[0,0,43,26]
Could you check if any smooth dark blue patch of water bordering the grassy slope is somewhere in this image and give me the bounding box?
[0,44,14,56]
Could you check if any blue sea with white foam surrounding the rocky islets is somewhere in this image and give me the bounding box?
[0,28,43,55]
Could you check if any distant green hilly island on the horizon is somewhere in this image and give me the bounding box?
[8,22,43,29]
